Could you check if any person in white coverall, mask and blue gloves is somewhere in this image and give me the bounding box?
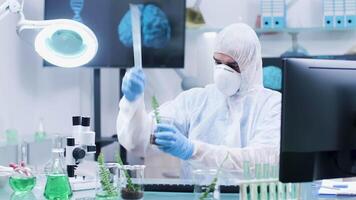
[117,23,281,178]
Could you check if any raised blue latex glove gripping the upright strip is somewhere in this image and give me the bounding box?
[121,67,145,102]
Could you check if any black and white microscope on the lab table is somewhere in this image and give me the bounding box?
[65,116,96,178]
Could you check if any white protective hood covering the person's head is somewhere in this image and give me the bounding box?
[214,23,263,94]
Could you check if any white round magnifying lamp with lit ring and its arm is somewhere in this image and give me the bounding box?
[0,0,98,68]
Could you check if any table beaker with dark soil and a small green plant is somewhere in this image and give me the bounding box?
[119,165,146,200]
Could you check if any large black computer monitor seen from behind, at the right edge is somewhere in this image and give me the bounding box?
[279,59,356,182]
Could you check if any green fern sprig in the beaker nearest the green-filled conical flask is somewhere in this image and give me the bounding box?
[98,153,118,197]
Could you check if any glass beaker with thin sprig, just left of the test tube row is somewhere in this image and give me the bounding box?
[193,169,220,200]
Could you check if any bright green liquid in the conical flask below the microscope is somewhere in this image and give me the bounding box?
[44,174,73,200]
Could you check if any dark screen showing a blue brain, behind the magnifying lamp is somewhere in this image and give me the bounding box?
[44,0,186,68]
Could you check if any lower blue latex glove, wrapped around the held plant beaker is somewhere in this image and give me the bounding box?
[155,124,194,160]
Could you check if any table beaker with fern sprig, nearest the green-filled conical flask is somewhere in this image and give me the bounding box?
[95,163,119,200]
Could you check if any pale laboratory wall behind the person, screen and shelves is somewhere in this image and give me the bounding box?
[0,0,355,159]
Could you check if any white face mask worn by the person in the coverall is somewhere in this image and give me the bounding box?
[214,64,241,96]
